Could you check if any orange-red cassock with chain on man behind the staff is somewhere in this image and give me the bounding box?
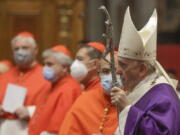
[59,88,118,135]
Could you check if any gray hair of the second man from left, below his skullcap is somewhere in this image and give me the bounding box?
[42,49,73,66]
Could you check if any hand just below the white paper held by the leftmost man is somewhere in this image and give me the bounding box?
[15,107,29,120]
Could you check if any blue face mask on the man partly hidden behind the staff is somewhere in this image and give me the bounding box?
[100,74,122,94]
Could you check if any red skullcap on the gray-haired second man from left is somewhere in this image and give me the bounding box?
[51,45,72,57]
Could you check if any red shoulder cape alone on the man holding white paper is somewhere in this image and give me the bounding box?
[0,65,51,110]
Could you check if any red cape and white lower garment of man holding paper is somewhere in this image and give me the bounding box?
[0,64,51,135]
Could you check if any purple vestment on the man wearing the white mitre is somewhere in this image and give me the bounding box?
[124,83,180,135]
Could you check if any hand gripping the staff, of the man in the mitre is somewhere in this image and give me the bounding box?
[110,87,129,111]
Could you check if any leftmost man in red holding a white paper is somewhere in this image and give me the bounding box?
[0,32,50,135]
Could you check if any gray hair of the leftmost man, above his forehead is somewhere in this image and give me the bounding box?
[11,35,37,48]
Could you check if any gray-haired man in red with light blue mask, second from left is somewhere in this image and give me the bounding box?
[29,45,82,135]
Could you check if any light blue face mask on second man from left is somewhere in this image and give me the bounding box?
[43,66,58,82]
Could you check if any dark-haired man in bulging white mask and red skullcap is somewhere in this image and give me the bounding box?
[71,42,105,91]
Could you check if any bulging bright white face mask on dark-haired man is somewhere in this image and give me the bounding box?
[70,60,88,81]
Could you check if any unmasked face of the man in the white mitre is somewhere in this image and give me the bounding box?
[117,57,140,90]
